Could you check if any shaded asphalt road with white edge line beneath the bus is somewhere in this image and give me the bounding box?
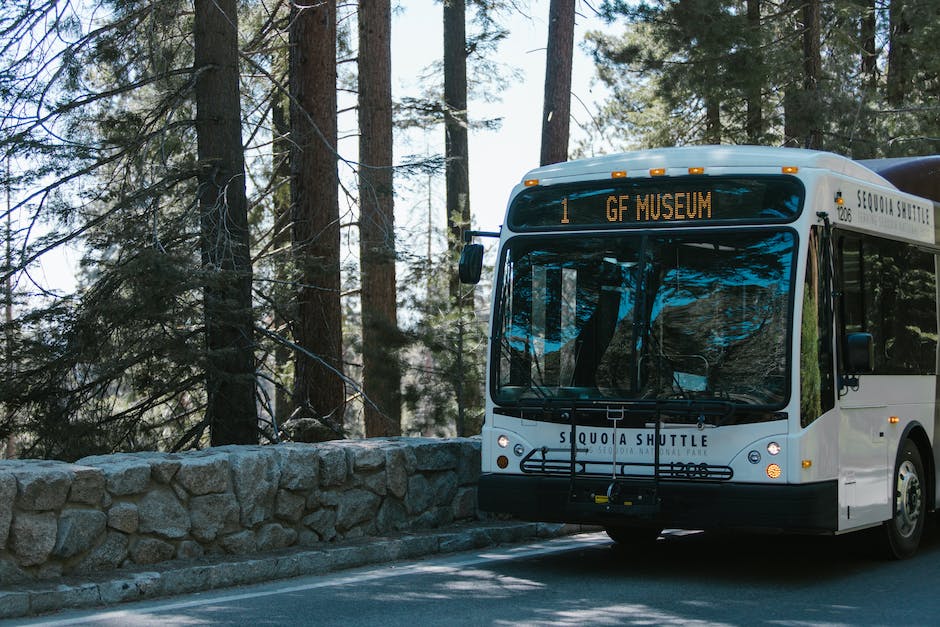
[17,529,940,627]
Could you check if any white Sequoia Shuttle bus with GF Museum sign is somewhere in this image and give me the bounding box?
[461,146,940,558]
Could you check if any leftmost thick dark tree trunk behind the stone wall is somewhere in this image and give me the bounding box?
[193,0,258,446]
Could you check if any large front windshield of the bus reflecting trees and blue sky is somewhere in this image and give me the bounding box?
[492,229,796,409]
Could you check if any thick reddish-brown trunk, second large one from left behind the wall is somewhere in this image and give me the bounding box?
[289,0,345,435]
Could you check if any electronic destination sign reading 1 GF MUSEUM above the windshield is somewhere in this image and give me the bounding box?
[508,176,805,231]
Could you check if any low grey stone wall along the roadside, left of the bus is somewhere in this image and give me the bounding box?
[0,438,480,584]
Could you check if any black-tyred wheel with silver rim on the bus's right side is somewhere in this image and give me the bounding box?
[884,440,926,559]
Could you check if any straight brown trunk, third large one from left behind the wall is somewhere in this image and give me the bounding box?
[359,0,401,437]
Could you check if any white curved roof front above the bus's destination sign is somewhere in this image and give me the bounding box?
[523,145,890,187]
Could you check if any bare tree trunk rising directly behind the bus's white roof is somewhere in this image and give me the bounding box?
[540,0,574,165]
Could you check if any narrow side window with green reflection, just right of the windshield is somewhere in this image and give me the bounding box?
[800,227,835,427]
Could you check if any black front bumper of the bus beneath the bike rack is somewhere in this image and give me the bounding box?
[479,473,839,533]
